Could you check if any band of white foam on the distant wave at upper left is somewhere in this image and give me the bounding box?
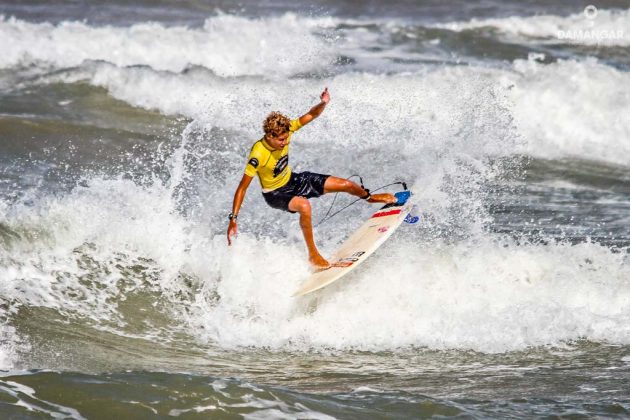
[0,13,333,77]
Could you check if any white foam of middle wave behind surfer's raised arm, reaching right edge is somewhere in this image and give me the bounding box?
[56,51,630,164]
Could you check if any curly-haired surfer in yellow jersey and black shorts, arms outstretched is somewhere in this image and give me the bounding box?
[227,88,396,269]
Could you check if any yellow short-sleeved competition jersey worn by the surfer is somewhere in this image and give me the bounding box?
[245,119,302,192]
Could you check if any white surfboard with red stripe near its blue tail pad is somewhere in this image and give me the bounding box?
[293,192,412,296]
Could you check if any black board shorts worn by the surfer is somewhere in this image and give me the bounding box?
[263,172,330,213]
